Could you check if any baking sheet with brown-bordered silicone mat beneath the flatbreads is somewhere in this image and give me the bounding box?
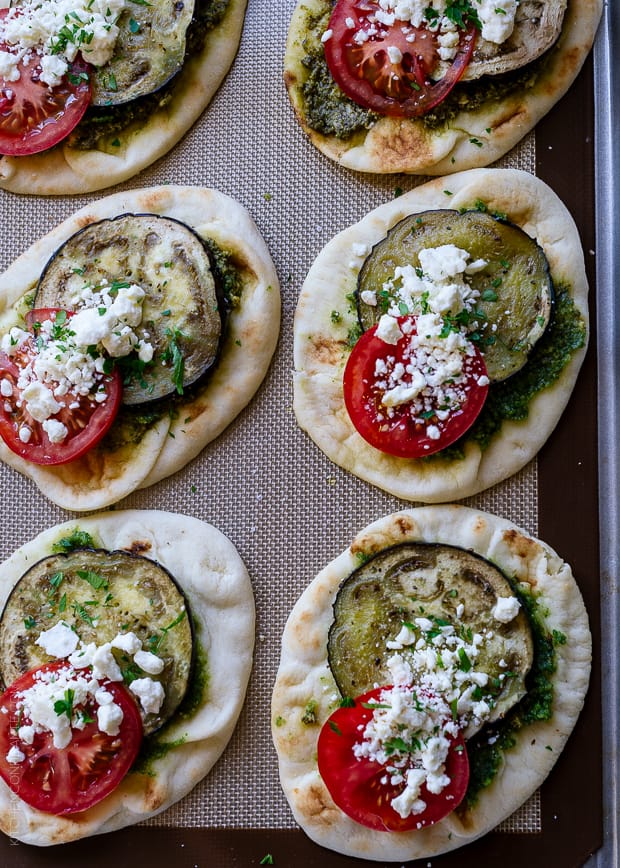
[0,0,604,868]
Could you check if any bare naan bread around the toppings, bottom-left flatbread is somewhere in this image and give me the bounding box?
[0,510,255,846]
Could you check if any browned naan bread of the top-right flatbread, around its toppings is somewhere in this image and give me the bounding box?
[284,0,603,175]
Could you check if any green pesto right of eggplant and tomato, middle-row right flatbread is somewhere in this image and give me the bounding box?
[423,286,586,461]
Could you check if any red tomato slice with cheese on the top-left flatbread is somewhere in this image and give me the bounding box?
[0,9,91,156]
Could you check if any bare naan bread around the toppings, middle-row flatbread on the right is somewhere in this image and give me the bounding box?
[293,169,588,503]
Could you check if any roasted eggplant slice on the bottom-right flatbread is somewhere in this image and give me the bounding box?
[328,543,533,719]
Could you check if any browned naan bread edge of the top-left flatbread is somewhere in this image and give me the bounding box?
[0,0,247,196]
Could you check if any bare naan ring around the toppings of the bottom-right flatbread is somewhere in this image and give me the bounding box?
[271,505,592,861]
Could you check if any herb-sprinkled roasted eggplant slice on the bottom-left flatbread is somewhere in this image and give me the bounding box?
[0,549,194,734]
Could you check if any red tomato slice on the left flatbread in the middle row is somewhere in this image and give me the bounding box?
[0,309,122,465]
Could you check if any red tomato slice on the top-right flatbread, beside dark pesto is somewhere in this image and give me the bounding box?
[324,0,477,118]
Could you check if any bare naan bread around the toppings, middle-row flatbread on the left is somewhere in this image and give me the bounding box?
[0,185,280,511]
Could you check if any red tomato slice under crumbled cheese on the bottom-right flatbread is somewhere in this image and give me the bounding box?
[318,687,469,832]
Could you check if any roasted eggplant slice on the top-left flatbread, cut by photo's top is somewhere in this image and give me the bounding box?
[86,0,194,106]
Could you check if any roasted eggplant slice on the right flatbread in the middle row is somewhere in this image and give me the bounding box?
[357,209,553,382]
